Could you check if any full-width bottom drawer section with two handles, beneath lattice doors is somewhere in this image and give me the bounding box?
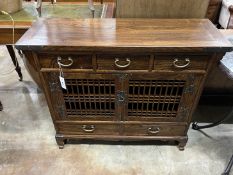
[56,122,187,136]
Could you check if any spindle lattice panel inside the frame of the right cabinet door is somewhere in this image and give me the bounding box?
[128,80,185,118]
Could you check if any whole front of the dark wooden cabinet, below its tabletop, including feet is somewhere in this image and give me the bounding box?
[32,52,215,150]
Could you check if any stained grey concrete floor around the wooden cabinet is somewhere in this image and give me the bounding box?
[0,46,233,175]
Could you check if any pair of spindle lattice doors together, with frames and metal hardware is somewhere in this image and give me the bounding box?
[46,72,203,122]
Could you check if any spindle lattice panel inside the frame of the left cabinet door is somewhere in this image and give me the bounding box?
[63,79,115,117]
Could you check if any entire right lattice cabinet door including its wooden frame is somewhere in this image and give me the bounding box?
[124,73,203,122]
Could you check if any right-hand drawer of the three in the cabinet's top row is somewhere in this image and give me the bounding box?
[154,54,210,71]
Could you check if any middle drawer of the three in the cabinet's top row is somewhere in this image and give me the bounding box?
[97,55,150,70]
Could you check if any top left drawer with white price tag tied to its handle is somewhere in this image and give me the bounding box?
[39,54,93,69]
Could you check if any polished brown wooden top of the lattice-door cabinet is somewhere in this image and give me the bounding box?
[16,19,232,52]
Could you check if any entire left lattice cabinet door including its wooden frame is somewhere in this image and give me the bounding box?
[43,72,118,121]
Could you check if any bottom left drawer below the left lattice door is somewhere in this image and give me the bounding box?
[56,123,120,135]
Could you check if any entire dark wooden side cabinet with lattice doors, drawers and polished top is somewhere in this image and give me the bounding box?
[17,19,231,150]
